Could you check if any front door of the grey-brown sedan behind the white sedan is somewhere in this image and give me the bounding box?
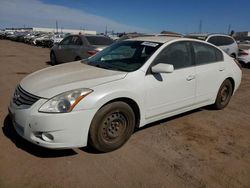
[55,36,72,62]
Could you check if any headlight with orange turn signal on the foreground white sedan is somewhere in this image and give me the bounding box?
[39,89,93,113]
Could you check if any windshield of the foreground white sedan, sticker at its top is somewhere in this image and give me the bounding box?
[84,41,162,72]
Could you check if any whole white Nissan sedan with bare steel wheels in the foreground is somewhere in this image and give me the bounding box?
[9,36,242,152]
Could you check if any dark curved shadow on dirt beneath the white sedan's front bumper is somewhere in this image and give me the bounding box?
[2,115,77,158]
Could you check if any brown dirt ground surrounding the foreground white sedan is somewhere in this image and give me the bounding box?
[0,40,250,188]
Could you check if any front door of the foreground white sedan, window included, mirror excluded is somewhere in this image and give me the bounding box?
[145,41,195,120]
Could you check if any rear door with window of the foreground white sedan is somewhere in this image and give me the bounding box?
[192,42,226,104]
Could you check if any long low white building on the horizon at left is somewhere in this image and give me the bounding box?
[5,27,97,35]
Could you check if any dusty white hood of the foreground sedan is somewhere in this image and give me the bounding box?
[20,61,127,98]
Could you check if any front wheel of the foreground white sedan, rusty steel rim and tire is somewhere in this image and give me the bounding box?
[89,102,135,152]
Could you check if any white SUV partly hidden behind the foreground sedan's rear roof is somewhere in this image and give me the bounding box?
[187,34,239,58]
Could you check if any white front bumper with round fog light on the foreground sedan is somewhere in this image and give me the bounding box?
[9,99,97,149]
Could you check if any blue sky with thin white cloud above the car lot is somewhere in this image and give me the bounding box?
[0,0,250,34]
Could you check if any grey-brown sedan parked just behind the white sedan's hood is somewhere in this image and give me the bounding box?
[50,35,114,65]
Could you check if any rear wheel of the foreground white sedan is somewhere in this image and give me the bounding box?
[213,80,233,110]
